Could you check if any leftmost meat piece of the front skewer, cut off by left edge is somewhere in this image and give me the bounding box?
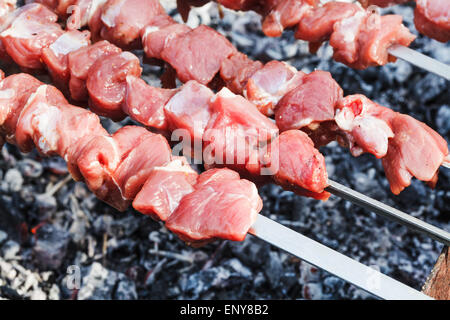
[0,73,42,144]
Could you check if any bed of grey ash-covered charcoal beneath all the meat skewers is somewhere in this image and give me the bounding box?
[0,1,450,299]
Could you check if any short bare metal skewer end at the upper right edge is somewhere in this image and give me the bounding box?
[388,45,450,80]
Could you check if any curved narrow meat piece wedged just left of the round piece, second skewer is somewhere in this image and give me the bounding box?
[67,41,121,101]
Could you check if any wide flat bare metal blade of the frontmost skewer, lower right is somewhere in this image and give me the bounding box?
[249,215,432,300]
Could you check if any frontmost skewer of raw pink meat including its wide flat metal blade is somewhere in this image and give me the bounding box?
[0,70,430,299]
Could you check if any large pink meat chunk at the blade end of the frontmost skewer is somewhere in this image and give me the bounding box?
[166,169,262,243]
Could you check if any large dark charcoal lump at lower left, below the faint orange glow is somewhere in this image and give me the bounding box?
[33,224,70,270]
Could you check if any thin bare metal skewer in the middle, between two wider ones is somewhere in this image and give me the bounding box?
[325,180,450,246]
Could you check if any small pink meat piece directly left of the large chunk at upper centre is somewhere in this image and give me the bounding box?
[141,15,192,59]
